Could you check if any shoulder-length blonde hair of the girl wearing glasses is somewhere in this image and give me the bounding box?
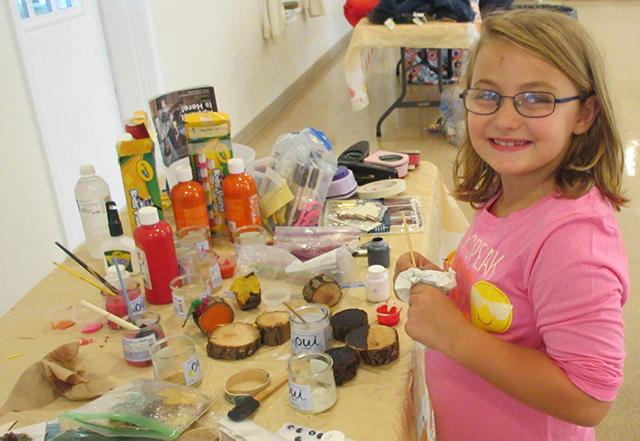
[453,9,628,210]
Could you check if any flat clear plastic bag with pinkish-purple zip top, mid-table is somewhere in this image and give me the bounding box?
[274,227,360,262]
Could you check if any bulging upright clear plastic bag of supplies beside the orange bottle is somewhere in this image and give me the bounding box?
[258,128,337,231]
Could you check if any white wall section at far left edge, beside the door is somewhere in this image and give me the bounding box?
[0,2,64,314]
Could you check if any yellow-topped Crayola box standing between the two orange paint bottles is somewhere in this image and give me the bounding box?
[184,112,233,235]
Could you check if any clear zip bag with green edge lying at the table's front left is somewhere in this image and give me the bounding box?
[60,379,211,440]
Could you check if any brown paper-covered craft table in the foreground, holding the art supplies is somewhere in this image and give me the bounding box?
[0,162,467,441]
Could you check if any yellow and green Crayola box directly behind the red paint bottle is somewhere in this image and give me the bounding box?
[116,138,163,232]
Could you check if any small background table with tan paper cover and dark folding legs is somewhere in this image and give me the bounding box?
[344,18,479,137]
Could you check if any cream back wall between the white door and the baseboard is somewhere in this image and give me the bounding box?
[148,0,351,131]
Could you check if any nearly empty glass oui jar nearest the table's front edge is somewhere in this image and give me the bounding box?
[287,352,336,414]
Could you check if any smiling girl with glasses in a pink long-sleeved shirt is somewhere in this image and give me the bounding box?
[396,10,629,441]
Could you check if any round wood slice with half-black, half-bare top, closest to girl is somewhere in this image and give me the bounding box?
[345,325,400,366]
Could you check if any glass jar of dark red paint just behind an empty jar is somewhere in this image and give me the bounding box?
[122,311,164,367]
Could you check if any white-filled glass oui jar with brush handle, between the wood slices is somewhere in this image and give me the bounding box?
[289,304,333,354]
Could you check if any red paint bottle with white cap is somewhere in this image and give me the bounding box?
[133,207,178,305]
